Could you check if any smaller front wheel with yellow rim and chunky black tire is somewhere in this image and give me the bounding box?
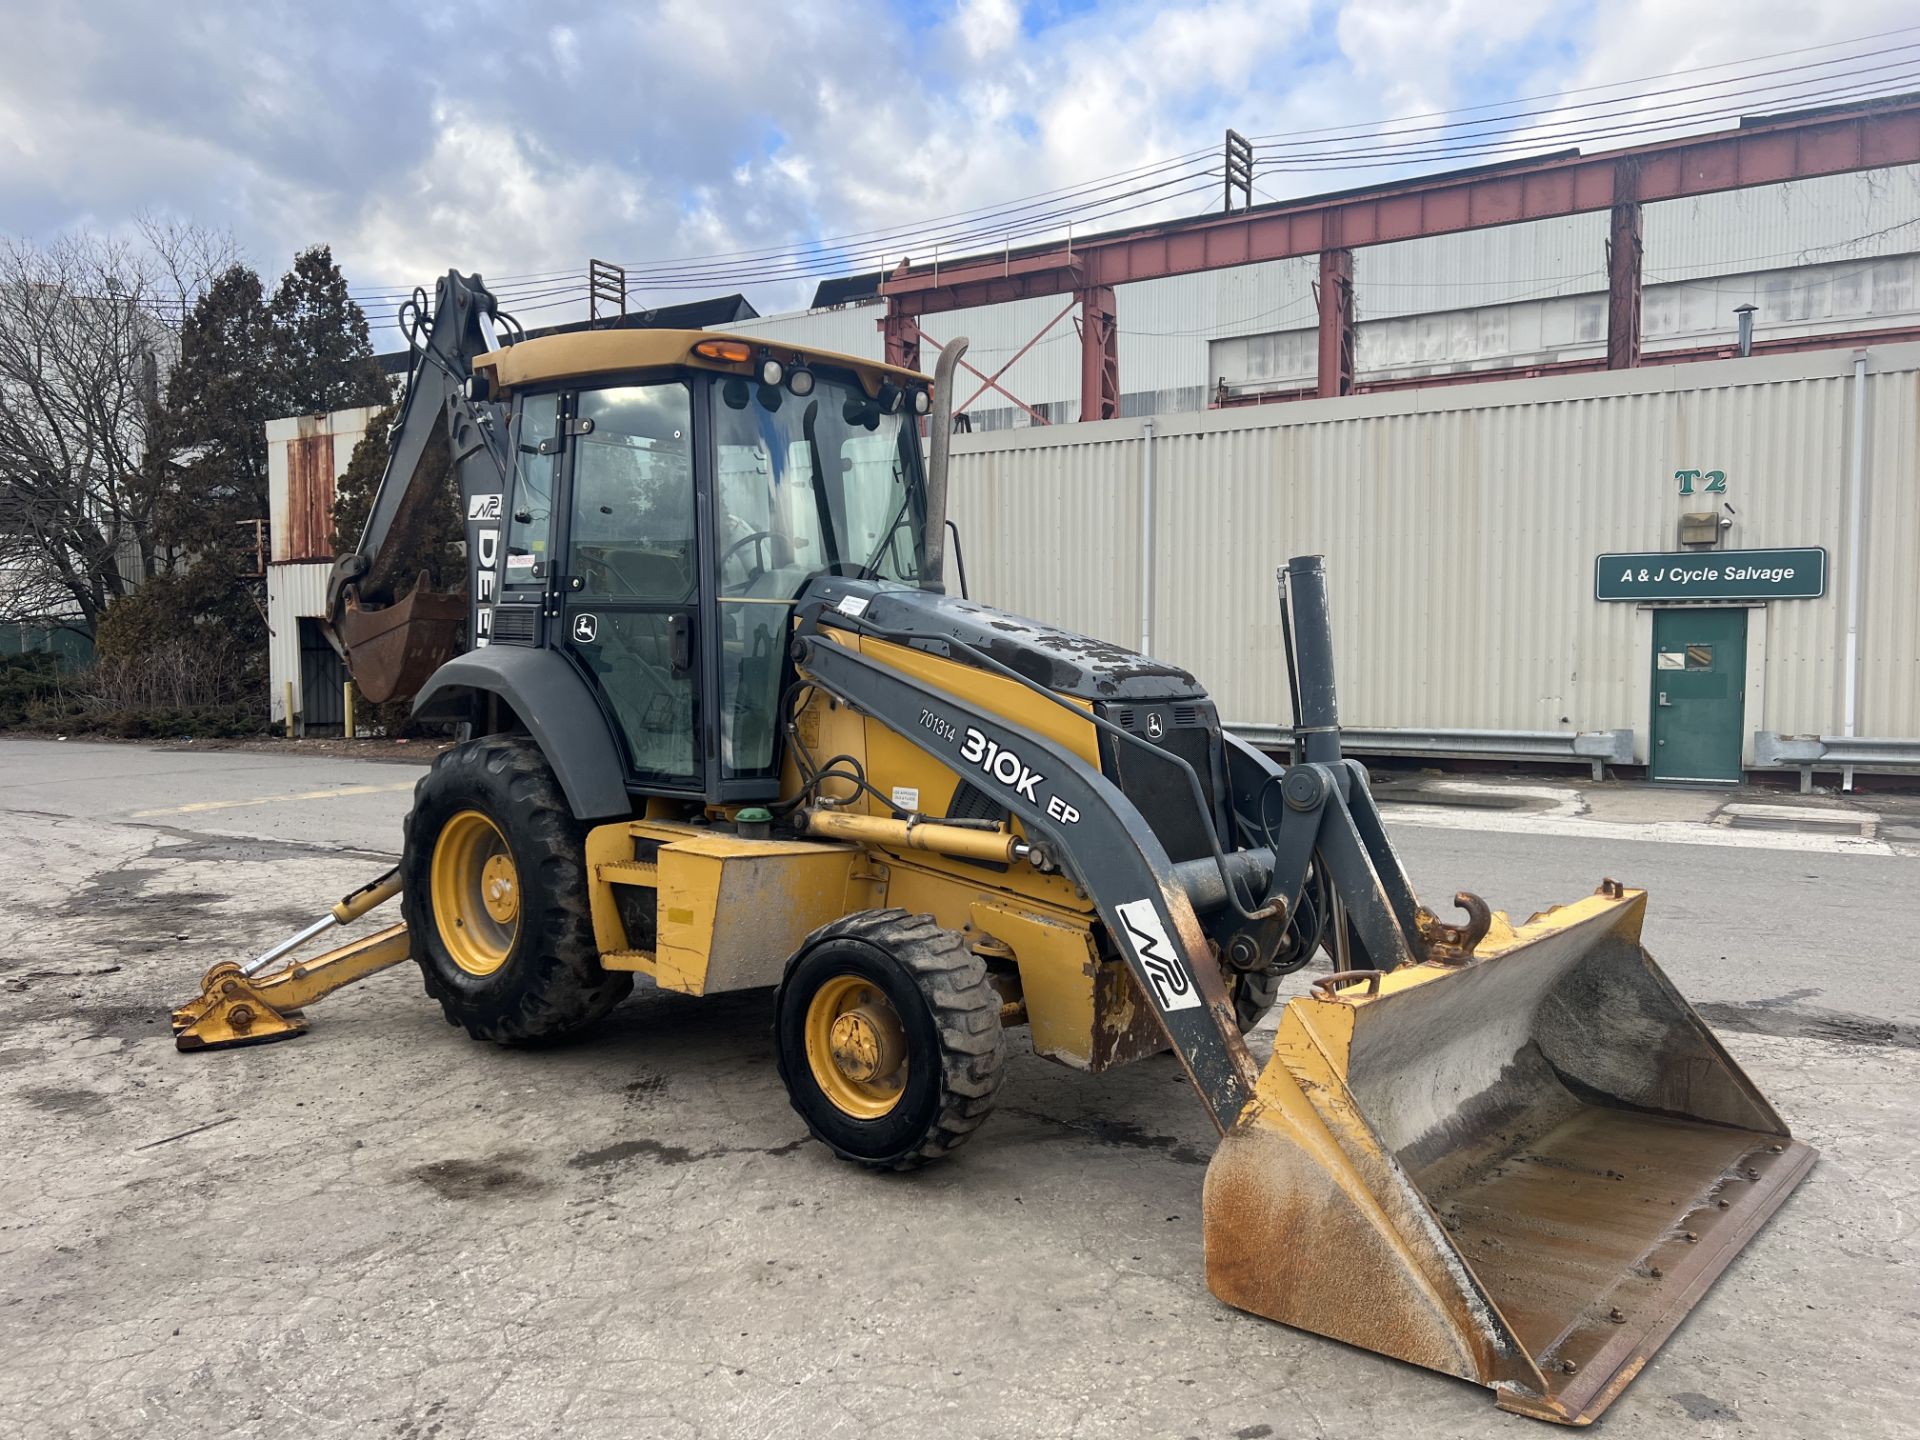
[774,910,1006,1169]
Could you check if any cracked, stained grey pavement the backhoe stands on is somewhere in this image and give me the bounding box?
[0,741,1920,1440]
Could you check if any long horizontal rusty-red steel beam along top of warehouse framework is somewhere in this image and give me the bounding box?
[879,98,1920,315]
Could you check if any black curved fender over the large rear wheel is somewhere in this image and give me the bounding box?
[413,645,634,820]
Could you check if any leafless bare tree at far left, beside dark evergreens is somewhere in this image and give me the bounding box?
[0,227,198,632]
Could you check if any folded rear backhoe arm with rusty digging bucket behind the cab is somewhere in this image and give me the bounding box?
[326,271,507,701]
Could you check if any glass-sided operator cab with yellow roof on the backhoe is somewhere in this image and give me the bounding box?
[474,330,929,803]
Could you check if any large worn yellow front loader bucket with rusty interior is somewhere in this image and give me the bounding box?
[1206,881,1814,1425]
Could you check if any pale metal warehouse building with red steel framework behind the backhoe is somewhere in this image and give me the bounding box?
[269,96,1920,783]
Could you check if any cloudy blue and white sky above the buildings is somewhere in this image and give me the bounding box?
[0,0,1920,343]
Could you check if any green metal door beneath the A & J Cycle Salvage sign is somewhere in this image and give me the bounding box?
[1649,609,1747,781]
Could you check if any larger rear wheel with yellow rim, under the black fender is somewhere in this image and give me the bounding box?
[399,735,634,1044]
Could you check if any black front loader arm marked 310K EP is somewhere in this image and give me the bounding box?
[795,629,1258,1135]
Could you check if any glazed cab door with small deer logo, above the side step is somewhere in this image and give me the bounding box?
[557,380,705,793]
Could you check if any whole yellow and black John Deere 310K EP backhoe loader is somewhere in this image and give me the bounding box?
[173,273,1814,1425]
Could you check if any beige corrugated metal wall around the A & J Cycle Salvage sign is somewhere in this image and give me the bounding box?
[952,346,1920,760]
